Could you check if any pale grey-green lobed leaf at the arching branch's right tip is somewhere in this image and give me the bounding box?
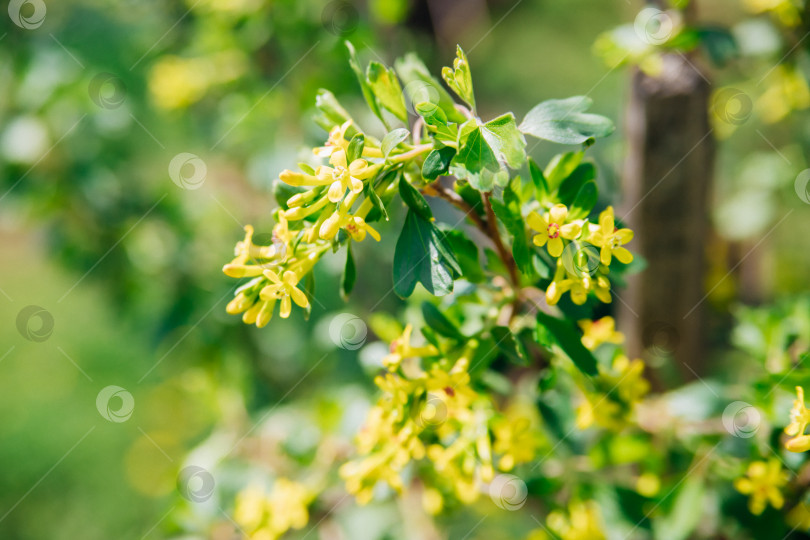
[520,96,615,144]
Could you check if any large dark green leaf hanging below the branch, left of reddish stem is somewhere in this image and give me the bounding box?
[394,210,461,298]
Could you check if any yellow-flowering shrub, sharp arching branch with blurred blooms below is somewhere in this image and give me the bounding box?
[213,41,648,538]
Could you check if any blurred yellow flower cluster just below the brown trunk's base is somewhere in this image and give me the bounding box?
[576,354,650,431]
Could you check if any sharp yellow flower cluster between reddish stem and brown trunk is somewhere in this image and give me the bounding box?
[527,204,633,305]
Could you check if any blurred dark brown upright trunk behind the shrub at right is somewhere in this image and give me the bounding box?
[617,22,715,380]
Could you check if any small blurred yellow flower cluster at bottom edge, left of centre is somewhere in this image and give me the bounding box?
[233,478,314,540]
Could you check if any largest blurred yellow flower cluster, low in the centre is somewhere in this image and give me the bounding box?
[340,326,542,513]
